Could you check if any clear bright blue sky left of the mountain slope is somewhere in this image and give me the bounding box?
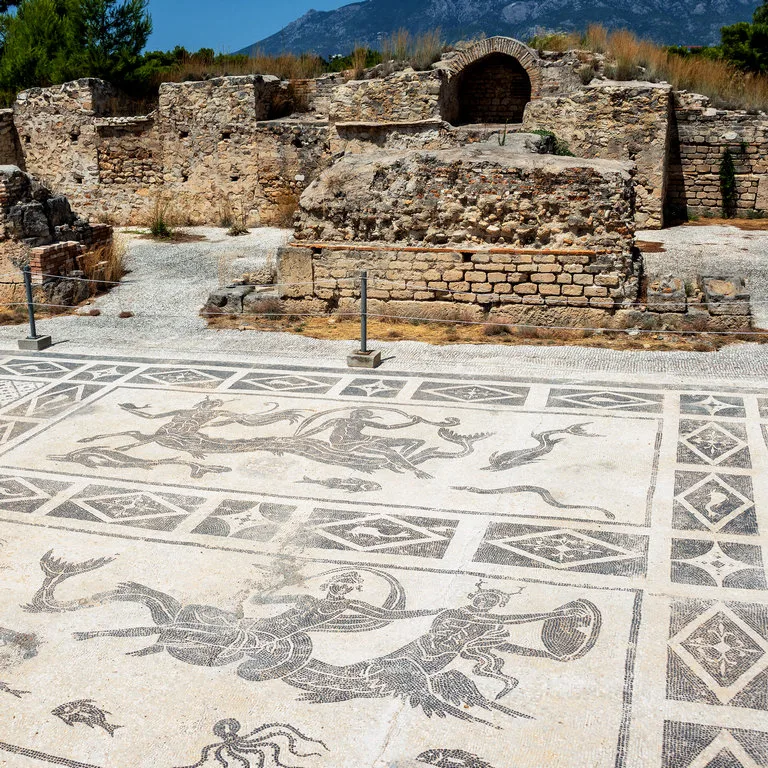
[148,0,352,53]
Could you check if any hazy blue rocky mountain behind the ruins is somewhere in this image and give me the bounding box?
[240,0,760,57]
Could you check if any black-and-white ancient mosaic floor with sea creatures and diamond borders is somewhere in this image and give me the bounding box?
[0,354,768,768]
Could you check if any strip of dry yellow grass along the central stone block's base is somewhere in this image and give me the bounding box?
[201,313,768,352]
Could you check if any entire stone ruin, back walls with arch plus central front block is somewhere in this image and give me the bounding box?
[0,37,768,327]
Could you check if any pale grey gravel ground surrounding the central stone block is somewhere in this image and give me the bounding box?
[0,226,768,383]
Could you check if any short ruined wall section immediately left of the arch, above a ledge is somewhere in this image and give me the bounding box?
[330,69,443,123]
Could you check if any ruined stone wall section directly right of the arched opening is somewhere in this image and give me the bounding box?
[523,82,671,228]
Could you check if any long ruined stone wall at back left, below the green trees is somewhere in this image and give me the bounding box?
[8,76,330,224]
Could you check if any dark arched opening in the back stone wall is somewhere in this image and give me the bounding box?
[456,52,532,125]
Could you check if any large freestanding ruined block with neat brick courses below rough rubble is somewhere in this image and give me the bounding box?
[278,145,638,310]
